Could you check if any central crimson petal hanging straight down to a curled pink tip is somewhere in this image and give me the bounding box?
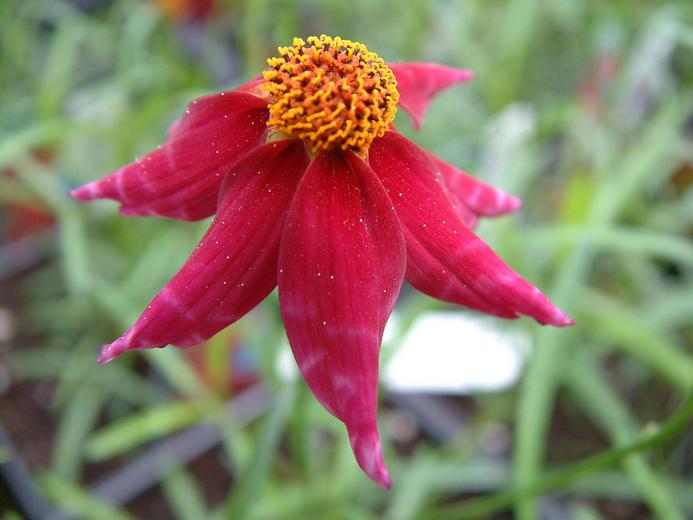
[279,152,406,488]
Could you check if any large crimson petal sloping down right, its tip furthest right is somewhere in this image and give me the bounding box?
[369,131,573,326]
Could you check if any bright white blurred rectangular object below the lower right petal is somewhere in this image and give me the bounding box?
[382,312,530,394]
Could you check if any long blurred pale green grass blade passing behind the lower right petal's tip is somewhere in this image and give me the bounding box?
[514,92,689,520]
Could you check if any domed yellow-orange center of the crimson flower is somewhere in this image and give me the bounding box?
[260,35,399,157]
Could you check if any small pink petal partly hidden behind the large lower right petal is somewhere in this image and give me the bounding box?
[427,152,522,217]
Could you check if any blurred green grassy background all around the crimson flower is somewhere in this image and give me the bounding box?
[0,0,693,520]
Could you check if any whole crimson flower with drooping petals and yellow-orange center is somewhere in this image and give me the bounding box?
[72,35,572,488]
